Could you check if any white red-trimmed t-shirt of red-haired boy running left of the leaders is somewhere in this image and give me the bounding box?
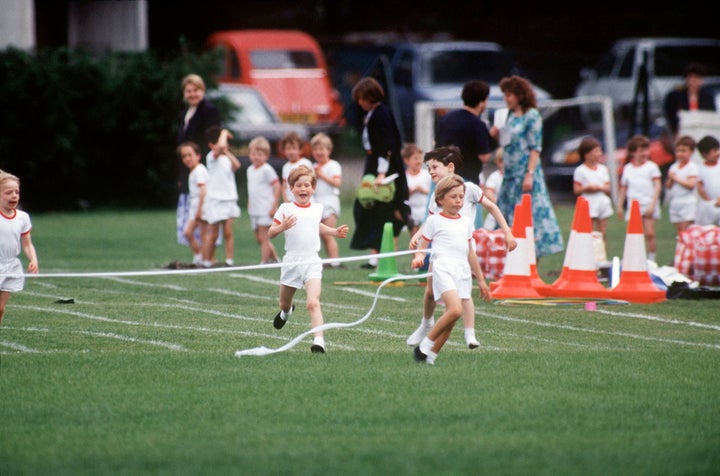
[273,202,323,254]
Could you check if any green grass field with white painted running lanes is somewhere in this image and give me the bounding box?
[0,198,720,476]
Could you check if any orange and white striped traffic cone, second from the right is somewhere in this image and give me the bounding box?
[548,197,609,298]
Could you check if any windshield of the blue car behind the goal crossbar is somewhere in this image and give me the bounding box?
[420,50,513,84]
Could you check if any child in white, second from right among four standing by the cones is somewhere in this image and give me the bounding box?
[665,136,698,235]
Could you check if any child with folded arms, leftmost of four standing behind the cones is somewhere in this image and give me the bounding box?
[573,137,613,244]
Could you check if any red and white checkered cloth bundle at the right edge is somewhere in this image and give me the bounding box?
[674,225,720,286]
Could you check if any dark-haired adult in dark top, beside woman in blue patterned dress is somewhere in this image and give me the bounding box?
[437,80,492,184]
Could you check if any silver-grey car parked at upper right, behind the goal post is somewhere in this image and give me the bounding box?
[575,38,720,127]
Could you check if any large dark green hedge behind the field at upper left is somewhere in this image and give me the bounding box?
[0,48,216,210]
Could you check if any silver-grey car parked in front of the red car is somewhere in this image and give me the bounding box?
[209,84,310,155]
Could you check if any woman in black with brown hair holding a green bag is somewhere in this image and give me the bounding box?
[350,77,410,269]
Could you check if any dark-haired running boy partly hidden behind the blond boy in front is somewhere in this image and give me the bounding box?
[406,146,517,349]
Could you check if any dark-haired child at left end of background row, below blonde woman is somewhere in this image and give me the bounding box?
[177,141,208,265]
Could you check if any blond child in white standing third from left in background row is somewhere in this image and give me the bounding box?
[246,136,280,264]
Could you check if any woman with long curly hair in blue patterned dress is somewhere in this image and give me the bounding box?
[490,76,564,258]
